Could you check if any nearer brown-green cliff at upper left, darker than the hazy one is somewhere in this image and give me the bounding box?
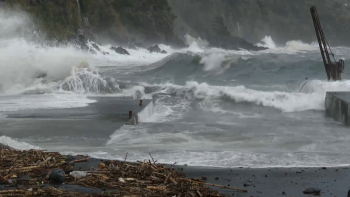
[5,0,181,45]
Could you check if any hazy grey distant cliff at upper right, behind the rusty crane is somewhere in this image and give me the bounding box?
[168,0,350,45]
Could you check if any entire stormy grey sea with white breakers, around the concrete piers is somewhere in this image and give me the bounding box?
[0,10,350,168]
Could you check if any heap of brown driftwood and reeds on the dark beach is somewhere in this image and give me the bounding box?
[0,147,247,197]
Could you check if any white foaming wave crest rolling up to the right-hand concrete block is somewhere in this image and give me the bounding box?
[185,82,342,112]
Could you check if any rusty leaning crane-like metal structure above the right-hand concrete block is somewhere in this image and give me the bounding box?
[310,6,345,81]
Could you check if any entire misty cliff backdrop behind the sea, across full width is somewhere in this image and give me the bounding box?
[0,0,350,50]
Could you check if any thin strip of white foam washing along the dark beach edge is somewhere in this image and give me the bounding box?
[54,149,350,168]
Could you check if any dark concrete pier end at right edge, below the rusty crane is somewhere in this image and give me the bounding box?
[325,92,350,126]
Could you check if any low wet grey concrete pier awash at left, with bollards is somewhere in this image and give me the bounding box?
[0,97,154,146]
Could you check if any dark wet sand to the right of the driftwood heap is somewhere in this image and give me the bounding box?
[55,158,350,197]
